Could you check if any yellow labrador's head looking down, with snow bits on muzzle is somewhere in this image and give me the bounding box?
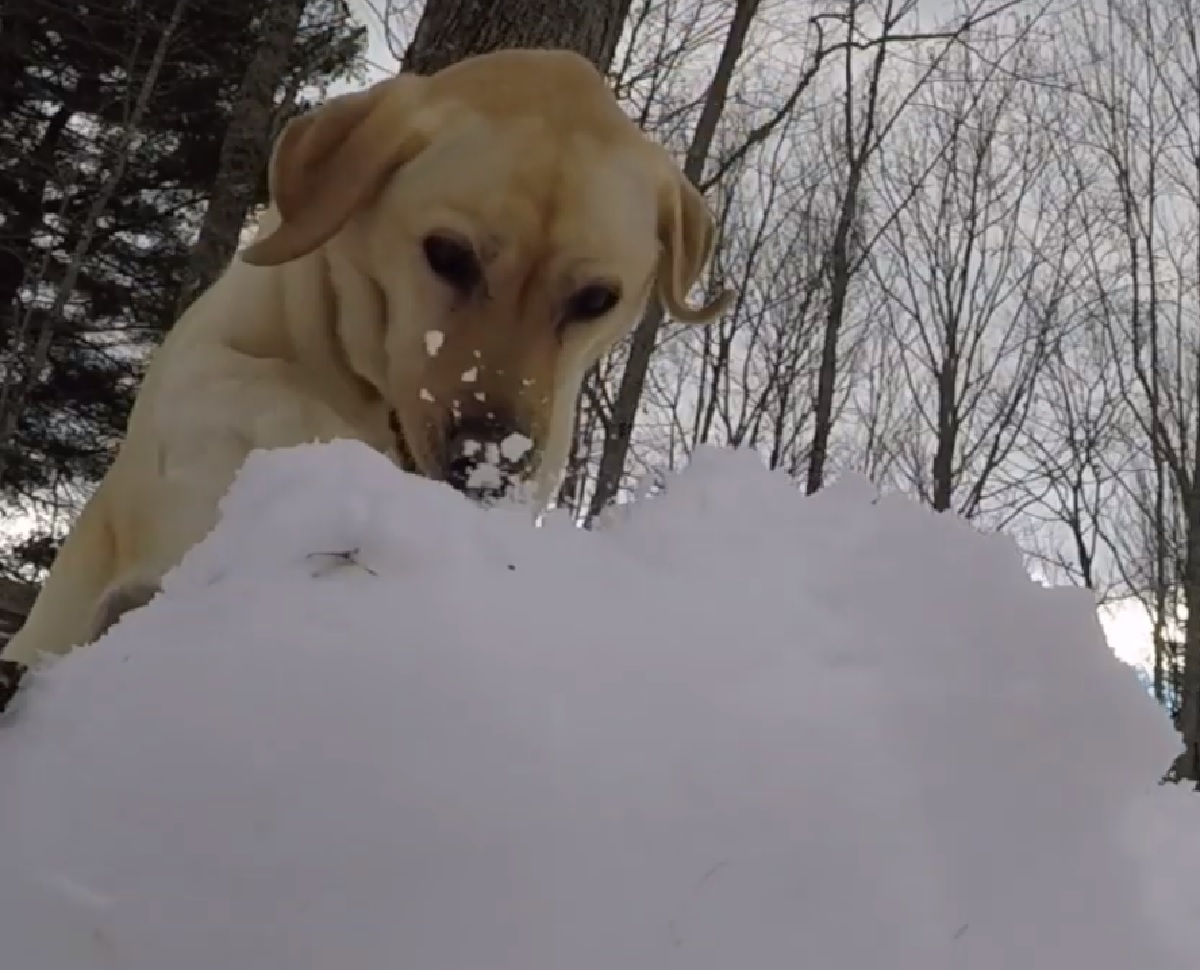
[242,50,728,497]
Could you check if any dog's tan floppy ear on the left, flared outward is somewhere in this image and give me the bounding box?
[241,74,428,267]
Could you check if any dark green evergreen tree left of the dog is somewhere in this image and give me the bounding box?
[0,0,365,573]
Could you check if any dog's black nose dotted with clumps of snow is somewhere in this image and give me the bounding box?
[445,413,533,499]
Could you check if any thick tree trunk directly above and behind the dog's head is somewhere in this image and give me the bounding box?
[403,0,630,74]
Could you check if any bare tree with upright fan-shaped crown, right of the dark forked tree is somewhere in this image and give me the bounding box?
[871,22,1076,520]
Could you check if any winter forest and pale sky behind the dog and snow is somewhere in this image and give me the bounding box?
[0,0,1200,779]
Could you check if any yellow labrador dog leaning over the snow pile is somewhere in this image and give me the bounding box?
[0,50,728,706]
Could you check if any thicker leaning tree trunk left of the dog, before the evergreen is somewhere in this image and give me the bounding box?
[176,0,305,312]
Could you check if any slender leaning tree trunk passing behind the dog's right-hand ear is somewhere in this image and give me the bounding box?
[588,0,758,521]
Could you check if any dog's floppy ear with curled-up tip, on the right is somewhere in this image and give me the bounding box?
[659,162,733,323]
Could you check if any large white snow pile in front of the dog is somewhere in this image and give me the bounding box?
[0,443,1200,970]
